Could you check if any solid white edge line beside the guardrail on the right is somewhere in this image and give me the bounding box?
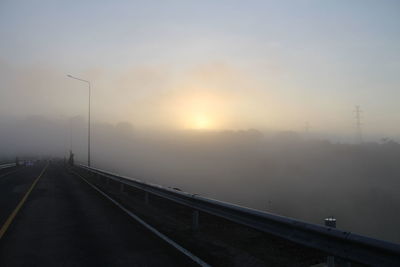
[71,170,211,267]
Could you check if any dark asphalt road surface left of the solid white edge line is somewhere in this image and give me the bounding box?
[0,163,194,266]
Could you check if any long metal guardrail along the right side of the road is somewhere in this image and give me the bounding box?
[79,165,400,266]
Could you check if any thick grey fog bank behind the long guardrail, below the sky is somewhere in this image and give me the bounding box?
[0,116,400,242]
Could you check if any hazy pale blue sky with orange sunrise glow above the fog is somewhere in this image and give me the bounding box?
[0,1,400,140]
